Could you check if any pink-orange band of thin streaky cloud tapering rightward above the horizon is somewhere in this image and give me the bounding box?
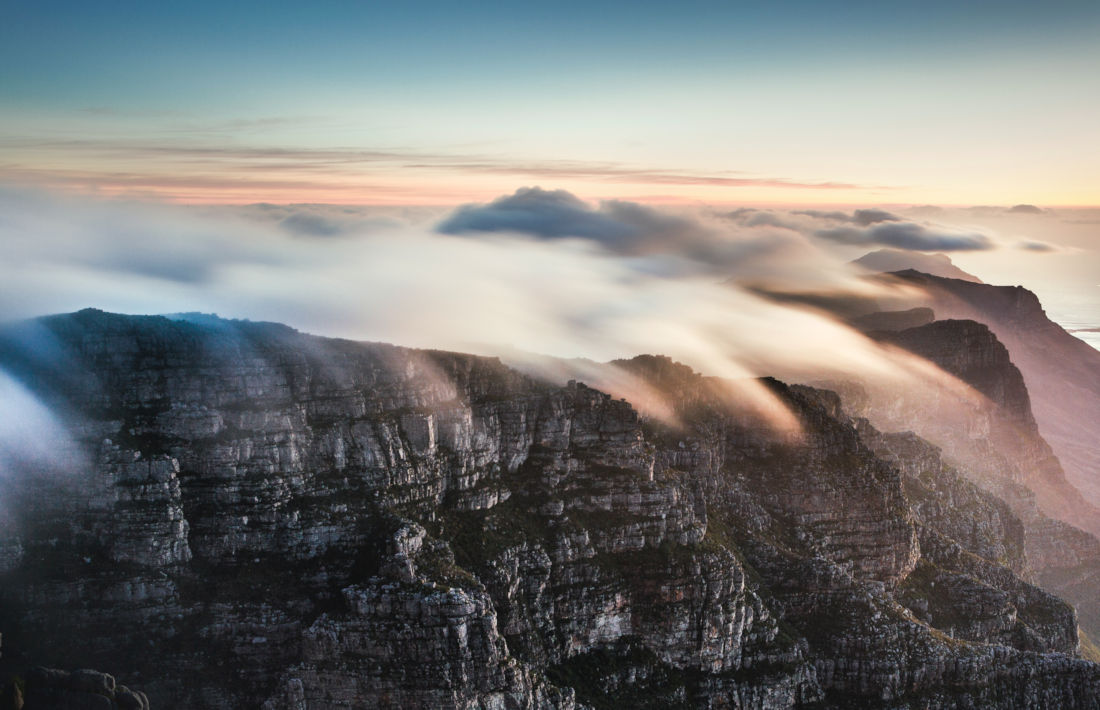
[0,136,889,201]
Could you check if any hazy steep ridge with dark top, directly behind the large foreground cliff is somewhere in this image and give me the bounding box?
[848,314,1100,633]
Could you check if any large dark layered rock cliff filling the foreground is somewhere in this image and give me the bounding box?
[0,312,1100,710]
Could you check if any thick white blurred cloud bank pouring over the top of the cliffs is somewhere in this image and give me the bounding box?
[0,183,1064,427]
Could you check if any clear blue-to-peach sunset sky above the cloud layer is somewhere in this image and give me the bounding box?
[0,0,1100,206]
